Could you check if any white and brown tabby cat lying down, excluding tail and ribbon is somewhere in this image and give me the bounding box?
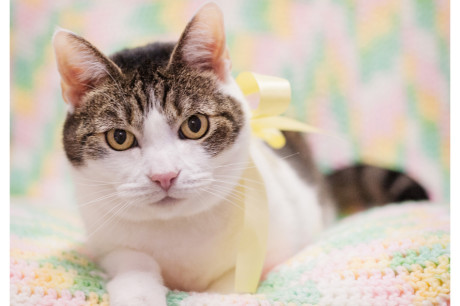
[53,3,428,305]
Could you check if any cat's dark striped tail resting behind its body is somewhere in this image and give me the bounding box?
[326,164,429,215]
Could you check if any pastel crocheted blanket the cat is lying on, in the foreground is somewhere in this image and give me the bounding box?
[10,199,450,306]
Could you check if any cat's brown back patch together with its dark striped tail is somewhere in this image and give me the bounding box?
[276,132,429,218]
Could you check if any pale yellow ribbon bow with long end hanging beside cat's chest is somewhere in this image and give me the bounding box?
[234,72,320,293]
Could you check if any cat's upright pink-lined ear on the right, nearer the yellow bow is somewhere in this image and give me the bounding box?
[168,3,231,82]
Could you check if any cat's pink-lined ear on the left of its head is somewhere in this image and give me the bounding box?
[53,29,121,108]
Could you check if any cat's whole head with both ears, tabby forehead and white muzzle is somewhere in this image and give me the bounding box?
[53,4,250,220]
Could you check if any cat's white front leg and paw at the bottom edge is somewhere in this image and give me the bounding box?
[100,249,168,306]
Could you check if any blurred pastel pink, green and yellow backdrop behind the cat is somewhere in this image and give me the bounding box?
[11,0,450,201]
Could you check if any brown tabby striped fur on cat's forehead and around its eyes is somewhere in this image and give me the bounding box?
[60,33,244,166]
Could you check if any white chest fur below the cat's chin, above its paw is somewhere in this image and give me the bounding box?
[81,183,242,291]
